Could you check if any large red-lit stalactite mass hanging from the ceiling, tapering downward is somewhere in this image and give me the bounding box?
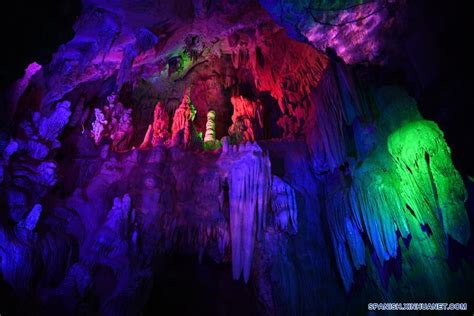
[249,31,328,136]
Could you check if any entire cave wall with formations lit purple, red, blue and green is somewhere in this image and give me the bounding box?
[0,1,473,315]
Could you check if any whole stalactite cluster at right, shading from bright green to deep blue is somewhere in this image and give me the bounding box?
[327,120,470,291]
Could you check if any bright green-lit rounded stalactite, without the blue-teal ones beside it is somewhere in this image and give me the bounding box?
[388,121,470,244]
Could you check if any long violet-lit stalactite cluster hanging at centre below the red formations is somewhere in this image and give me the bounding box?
[220,138,271,282]
